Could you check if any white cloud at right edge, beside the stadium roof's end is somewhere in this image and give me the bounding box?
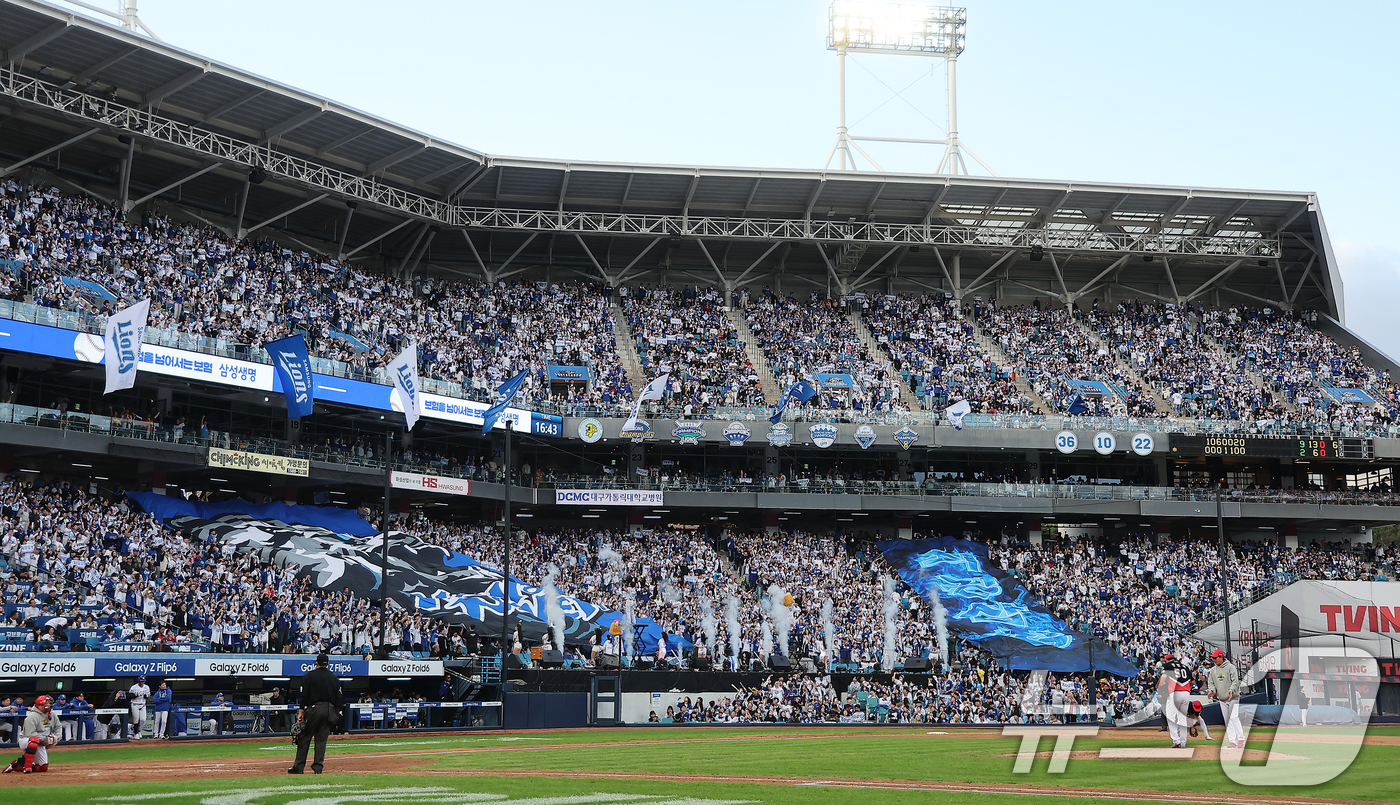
[1333,239,1400,360]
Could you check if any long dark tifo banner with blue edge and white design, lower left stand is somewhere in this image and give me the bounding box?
[127,491,635,650]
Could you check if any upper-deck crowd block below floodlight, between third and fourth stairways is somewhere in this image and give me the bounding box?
[861,294,1042,414]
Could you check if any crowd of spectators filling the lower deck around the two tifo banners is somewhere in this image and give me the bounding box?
[0,464,1393,722]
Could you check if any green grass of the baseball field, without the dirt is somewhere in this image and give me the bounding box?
[13,728,1400,805]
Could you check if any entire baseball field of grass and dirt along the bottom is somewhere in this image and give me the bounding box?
[0,727,1400,805]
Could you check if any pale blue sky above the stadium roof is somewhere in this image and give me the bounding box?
[84,0,1400,357]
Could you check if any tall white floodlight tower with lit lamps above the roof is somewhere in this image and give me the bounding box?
[825,0,997,176]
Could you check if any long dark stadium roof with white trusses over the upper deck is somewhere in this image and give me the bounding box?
[0,0,1344,321]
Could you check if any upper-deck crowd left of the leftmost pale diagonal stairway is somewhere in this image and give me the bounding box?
[0,179,631,405]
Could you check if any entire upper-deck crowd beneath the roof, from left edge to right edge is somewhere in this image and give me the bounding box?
[8,178,1400,434]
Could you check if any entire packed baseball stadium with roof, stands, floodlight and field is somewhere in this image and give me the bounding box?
[0,0,1400,805]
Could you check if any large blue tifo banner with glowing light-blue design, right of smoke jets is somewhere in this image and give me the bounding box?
[876,536,1138,676]
